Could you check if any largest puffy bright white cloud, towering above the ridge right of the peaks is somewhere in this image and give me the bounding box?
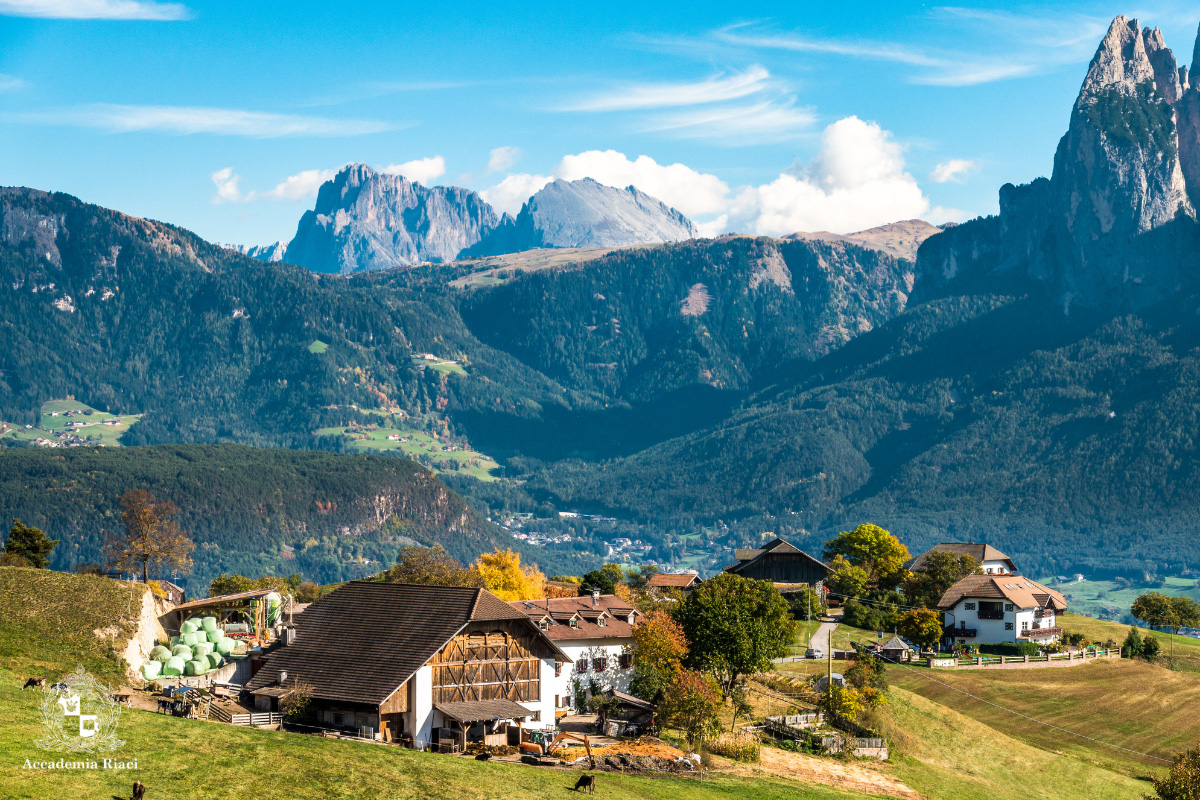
[725,116,930,236]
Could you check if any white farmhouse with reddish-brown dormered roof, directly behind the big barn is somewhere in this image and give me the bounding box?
[509,593,641,716]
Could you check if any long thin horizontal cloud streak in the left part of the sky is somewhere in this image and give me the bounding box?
[14,103,396,139]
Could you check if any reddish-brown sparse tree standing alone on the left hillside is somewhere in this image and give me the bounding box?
[104,489,194,583]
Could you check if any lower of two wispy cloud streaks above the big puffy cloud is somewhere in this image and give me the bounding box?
[646,98,817,144]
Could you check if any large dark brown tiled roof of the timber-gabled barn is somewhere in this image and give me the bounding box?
[247,581,566,705]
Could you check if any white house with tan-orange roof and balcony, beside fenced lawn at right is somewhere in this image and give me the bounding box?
[937,575,1067,646]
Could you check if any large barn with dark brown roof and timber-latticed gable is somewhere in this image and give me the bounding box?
[246,581,568,748]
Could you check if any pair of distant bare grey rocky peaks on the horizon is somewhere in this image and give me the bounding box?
[261,164,696,275]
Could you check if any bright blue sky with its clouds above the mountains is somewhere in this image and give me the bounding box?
[0,0,1200,243]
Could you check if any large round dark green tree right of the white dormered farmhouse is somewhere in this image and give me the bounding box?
[674,572,796,692]
